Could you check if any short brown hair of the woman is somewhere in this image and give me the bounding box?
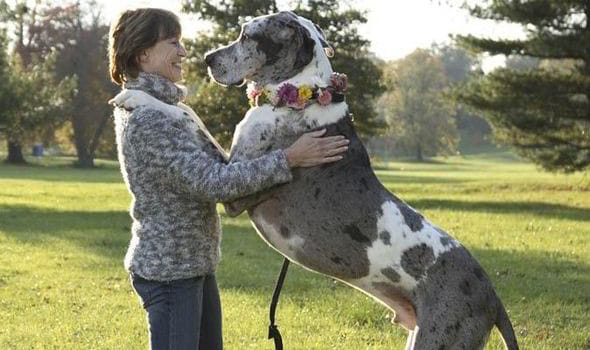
[109,8,181,85]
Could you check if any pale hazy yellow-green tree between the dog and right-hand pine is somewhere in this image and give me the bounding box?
[378,49,458,161]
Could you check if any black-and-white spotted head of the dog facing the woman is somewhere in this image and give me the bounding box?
[205,11,331,85]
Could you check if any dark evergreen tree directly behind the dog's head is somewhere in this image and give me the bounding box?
[183,0,382,145]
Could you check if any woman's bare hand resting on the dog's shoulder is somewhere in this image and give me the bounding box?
[285,129,350,168]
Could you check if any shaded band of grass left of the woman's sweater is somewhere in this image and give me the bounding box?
[0,205,131,258]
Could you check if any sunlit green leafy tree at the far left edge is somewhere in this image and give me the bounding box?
[0,0,75,163]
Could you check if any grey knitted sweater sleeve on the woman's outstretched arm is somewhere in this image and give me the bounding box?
[130,109,292,202]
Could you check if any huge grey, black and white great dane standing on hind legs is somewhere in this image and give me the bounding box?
[116,11,518,350]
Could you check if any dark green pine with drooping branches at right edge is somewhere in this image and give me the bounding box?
[456,0,590,172]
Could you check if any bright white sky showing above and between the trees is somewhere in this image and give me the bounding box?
[98,0,523,70]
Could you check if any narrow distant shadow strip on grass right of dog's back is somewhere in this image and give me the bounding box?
[410,199,590,221]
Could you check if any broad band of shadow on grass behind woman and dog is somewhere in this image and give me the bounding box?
[0,204,590,312]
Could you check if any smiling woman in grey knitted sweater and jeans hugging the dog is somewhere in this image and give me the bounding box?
[109,9,348,350]
